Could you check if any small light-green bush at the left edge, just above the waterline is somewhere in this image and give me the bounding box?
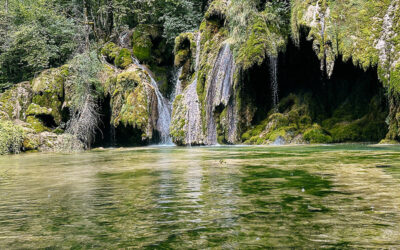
[0,120,24,155]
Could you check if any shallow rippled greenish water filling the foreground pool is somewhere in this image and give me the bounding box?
[0,145,400,249]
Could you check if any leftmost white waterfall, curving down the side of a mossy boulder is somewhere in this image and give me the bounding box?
[132,57,172,144]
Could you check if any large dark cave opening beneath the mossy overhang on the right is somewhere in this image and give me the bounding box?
[241,28,388,141]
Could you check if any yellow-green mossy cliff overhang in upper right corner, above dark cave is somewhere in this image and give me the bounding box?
[291,0,400,84]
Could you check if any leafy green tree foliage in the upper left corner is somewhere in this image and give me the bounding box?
[0,0,81,88]
